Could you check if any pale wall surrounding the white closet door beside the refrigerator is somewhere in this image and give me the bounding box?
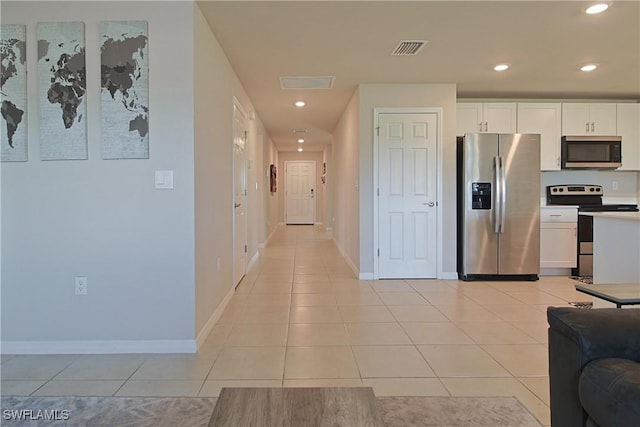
[359,84,456,277]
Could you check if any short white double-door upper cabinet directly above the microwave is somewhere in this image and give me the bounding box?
[562,103,616,135]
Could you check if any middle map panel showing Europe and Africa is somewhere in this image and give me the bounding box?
[37,22,88,160]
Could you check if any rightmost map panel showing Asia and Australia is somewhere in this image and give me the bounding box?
[100,21,149,159]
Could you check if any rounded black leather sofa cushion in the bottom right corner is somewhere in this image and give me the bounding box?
[578,358,640,427]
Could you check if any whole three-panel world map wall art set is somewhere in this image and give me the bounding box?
[0,21,149,162]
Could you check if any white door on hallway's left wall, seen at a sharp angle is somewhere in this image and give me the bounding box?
[233,104,248,286]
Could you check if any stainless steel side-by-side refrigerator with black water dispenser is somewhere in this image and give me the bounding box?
[457,133,540,280]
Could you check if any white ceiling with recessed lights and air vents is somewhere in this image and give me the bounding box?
[198,0,640,150]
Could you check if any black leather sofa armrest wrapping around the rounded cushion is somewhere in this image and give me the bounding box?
[547,307,640,427]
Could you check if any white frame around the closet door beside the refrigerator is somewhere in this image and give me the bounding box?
[372,107,445,280]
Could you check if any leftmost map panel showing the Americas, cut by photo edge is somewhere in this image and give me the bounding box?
[0,24,27,162]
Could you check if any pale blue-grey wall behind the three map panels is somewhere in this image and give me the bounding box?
[1,1,195,352]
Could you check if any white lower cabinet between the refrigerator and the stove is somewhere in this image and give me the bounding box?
[540,207,578,268]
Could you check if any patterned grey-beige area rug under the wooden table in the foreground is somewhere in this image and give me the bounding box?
[1,396,542,427]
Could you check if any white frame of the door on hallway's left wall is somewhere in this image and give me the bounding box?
[231,96,250,288]
